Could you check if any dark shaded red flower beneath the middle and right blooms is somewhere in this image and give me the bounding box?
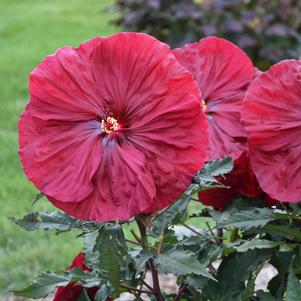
[199,153,263,210]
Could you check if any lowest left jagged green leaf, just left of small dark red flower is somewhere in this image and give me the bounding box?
[12,272,71,299]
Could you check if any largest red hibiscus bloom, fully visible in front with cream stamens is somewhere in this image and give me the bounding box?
[19,33,208,222]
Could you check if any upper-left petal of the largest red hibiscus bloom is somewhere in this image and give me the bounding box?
[29,37,104,121]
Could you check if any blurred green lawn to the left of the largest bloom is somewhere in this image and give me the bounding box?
[0,0,118,296]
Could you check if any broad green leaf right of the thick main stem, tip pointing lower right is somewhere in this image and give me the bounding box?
[154,249,215,280]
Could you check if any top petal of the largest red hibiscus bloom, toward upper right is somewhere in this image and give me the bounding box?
[93,33,200,121]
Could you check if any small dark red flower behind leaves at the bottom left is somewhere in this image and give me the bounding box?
[53,253,99,301]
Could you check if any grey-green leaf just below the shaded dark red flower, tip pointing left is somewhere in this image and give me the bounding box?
[219,208,274,230]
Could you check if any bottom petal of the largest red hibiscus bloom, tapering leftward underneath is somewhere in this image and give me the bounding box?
[49,141,160,222]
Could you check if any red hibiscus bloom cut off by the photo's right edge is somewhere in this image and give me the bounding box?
[242,60,301,202]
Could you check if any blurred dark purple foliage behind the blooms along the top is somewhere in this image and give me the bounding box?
[111,0,301,70]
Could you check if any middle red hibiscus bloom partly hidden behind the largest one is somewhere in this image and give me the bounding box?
[174,37,256,160]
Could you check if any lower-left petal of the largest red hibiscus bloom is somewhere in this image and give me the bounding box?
[19,105,102,202]
